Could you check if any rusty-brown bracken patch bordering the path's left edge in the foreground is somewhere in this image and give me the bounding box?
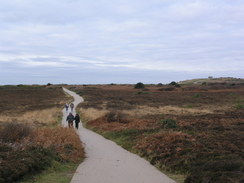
[0,123,84,162]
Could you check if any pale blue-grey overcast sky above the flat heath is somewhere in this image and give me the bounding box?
[0,0,244,84]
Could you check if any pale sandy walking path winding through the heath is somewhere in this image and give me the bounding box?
[62,88,175,183]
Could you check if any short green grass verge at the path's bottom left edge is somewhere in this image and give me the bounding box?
[18,161,81,183]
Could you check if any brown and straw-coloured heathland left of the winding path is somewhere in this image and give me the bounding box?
[0,85,84,183]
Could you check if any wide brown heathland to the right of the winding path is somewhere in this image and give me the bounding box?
[70,78,244,183]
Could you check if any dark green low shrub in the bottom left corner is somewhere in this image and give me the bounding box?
[0,147,55,183]
